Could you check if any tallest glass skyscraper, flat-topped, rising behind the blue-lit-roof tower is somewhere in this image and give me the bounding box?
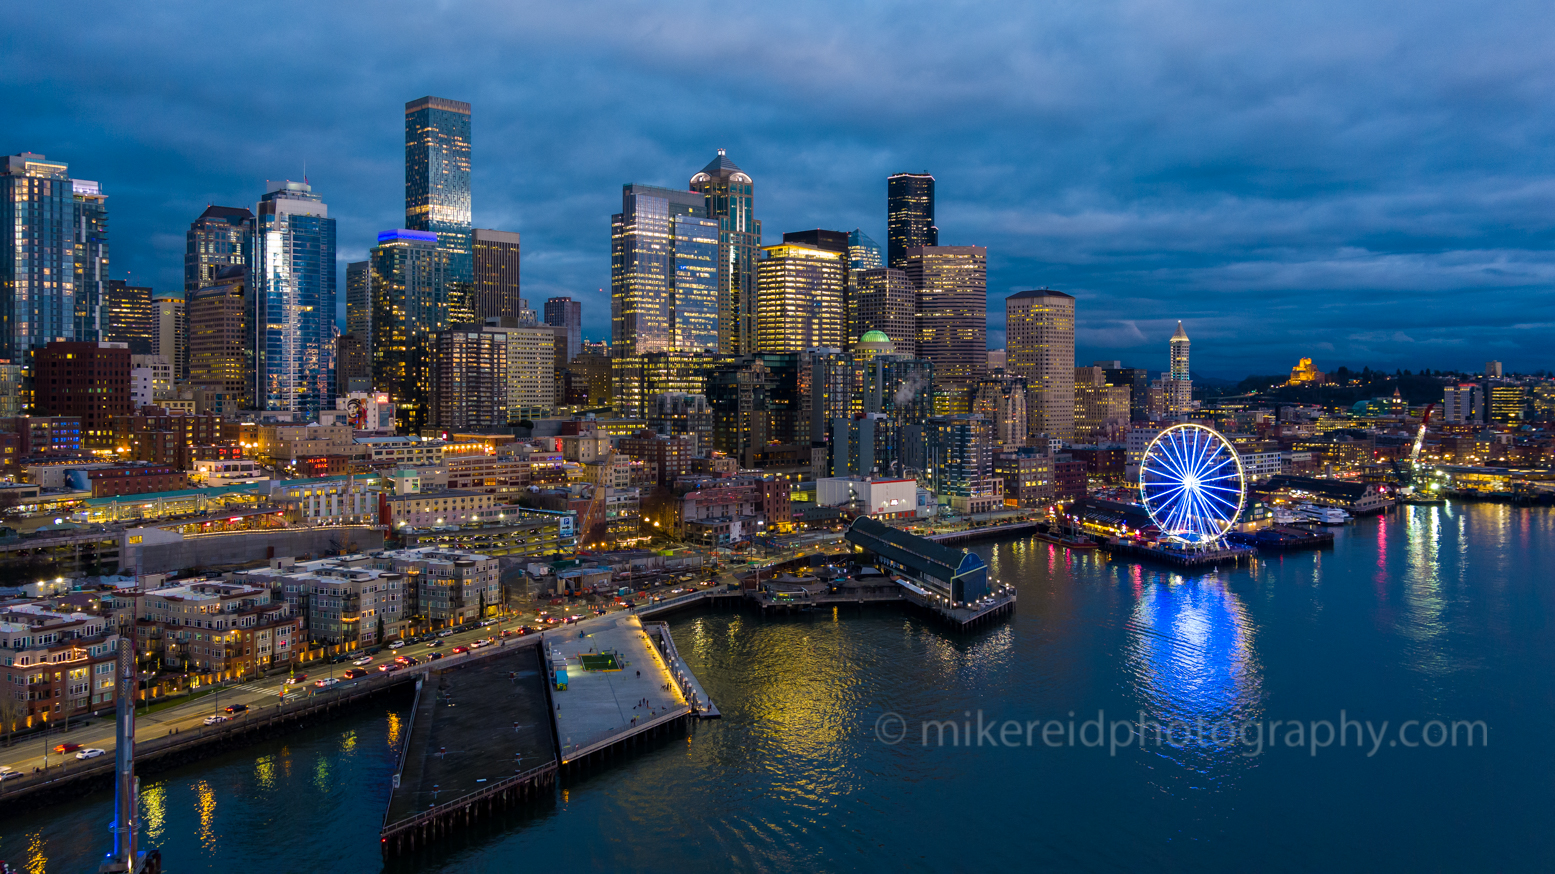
[404,96,474,283]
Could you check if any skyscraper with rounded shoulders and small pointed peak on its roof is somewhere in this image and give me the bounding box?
[690,149,762,355]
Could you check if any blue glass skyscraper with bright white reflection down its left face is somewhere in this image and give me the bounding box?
[253,182,334,414]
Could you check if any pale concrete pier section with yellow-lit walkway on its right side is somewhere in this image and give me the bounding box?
[544,613,706,767]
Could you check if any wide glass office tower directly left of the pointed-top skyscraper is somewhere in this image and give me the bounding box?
[610,185,723,358]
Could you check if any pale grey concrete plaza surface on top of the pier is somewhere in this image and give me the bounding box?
[546,614,687,749]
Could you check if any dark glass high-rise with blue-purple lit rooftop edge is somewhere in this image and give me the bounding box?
[369,229,449,431]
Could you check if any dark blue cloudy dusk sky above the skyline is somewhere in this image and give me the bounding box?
[0,0,1555,378]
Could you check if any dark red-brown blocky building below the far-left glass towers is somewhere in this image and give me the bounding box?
[33,341,131,449]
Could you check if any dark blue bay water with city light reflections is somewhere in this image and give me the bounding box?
[0,505,1555,874]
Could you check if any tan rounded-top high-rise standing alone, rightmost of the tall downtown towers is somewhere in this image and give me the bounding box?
[1005,288,1075,440]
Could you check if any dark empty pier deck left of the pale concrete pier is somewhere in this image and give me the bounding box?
[379,645,557,858]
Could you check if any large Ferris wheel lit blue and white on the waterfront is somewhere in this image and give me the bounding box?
[1140,425,1247,544]
